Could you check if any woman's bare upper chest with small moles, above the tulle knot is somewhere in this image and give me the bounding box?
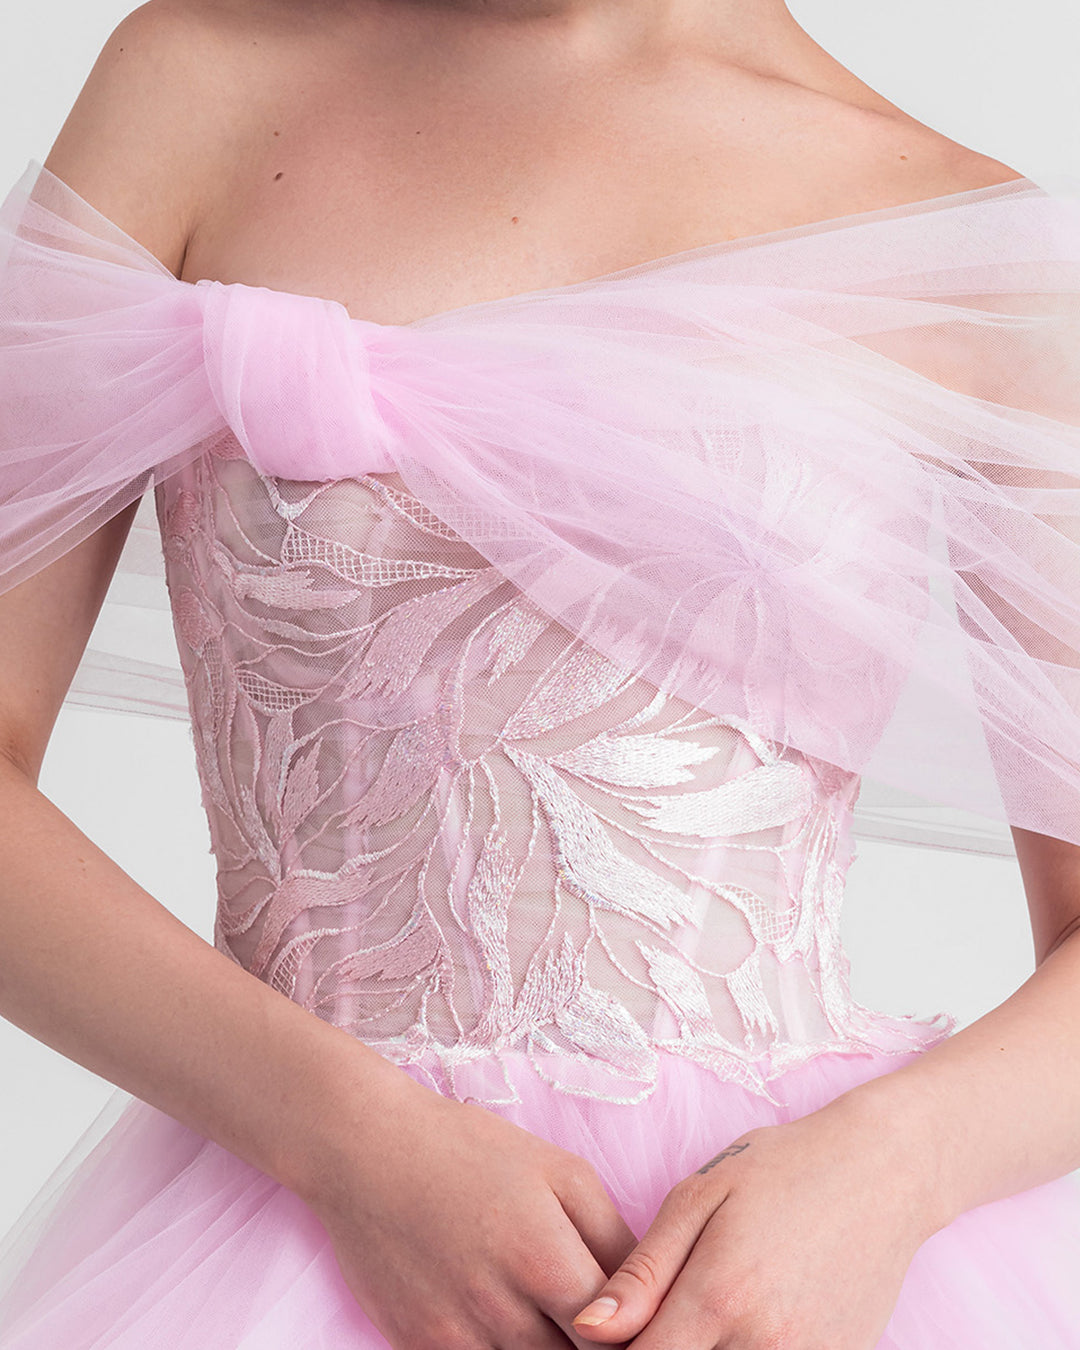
[175,38,945,324]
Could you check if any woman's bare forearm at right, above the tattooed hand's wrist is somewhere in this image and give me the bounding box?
[825,932,1080,1231]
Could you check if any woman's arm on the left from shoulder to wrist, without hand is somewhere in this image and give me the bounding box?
[0,5,417,1204]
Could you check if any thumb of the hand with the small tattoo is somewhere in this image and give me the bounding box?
[572,1192,707,1343]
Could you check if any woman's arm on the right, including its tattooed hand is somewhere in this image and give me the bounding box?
[575,830,1080,1350]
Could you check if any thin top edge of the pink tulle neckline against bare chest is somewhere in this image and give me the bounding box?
[26,159,1050,331]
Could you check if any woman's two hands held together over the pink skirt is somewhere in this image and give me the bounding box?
[302,1073,941,1350]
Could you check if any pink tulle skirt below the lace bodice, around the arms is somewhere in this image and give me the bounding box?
[0,1052,1080,1350]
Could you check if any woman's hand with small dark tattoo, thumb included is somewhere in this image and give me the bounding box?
[564,1098,946,1350]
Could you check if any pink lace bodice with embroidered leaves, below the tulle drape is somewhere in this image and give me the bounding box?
[157,436,952,1102]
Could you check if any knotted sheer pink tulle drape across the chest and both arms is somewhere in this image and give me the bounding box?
[0,157,1080,842]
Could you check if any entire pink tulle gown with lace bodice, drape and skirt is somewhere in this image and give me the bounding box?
[0,155,1080,1350]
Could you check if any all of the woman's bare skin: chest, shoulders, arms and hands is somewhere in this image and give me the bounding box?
[0,0,1080,1350]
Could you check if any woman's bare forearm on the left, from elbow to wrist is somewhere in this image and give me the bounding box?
[0,755,419,1193]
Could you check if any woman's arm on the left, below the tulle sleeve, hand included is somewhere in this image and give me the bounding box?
[0,504,633,1350]
